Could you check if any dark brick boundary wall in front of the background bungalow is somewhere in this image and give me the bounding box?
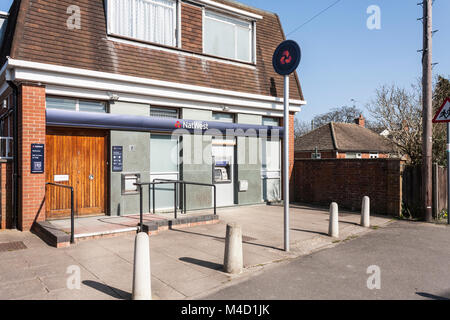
[293,159,404,216]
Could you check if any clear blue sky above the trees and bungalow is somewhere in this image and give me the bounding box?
[0,0,450,122]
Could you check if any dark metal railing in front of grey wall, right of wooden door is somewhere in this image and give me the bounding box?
[134,179,217,230]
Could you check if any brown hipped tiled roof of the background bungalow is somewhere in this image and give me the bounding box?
[295,122,395,153]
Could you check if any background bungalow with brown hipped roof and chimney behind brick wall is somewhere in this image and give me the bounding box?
[295,115,396,159]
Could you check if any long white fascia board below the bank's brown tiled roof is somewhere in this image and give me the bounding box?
[8,59,306,112]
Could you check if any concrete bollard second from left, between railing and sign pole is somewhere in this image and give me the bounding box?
[223,223,244,274]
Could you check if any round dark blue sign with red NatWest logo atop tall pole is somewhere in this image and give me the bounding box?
[272,40,302,76]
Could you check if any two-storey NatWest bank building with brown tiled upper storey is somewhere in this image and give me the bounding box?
[0,0,305,230]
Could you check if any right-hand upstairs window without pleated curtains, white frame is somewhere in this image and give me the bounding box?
[203,11,254,62]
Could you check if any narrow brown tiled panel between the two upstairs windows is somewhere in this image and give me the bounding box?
[181,2,203,53]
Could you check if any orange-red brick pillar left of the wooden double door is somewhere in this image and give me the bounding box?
[18,84,45,231]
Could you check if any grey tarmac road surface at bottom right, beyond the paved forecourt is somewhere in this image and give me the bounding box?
[205,221,450,300]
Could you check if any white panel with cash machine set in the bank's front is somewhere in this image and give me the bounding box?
[212,139,236,207]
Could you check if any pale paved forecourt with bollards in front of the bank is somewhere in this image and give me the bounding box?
[0,205,391,300]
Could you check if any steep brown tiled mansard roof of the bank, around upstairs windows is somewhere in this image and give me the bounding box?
[0,0,303,100]
